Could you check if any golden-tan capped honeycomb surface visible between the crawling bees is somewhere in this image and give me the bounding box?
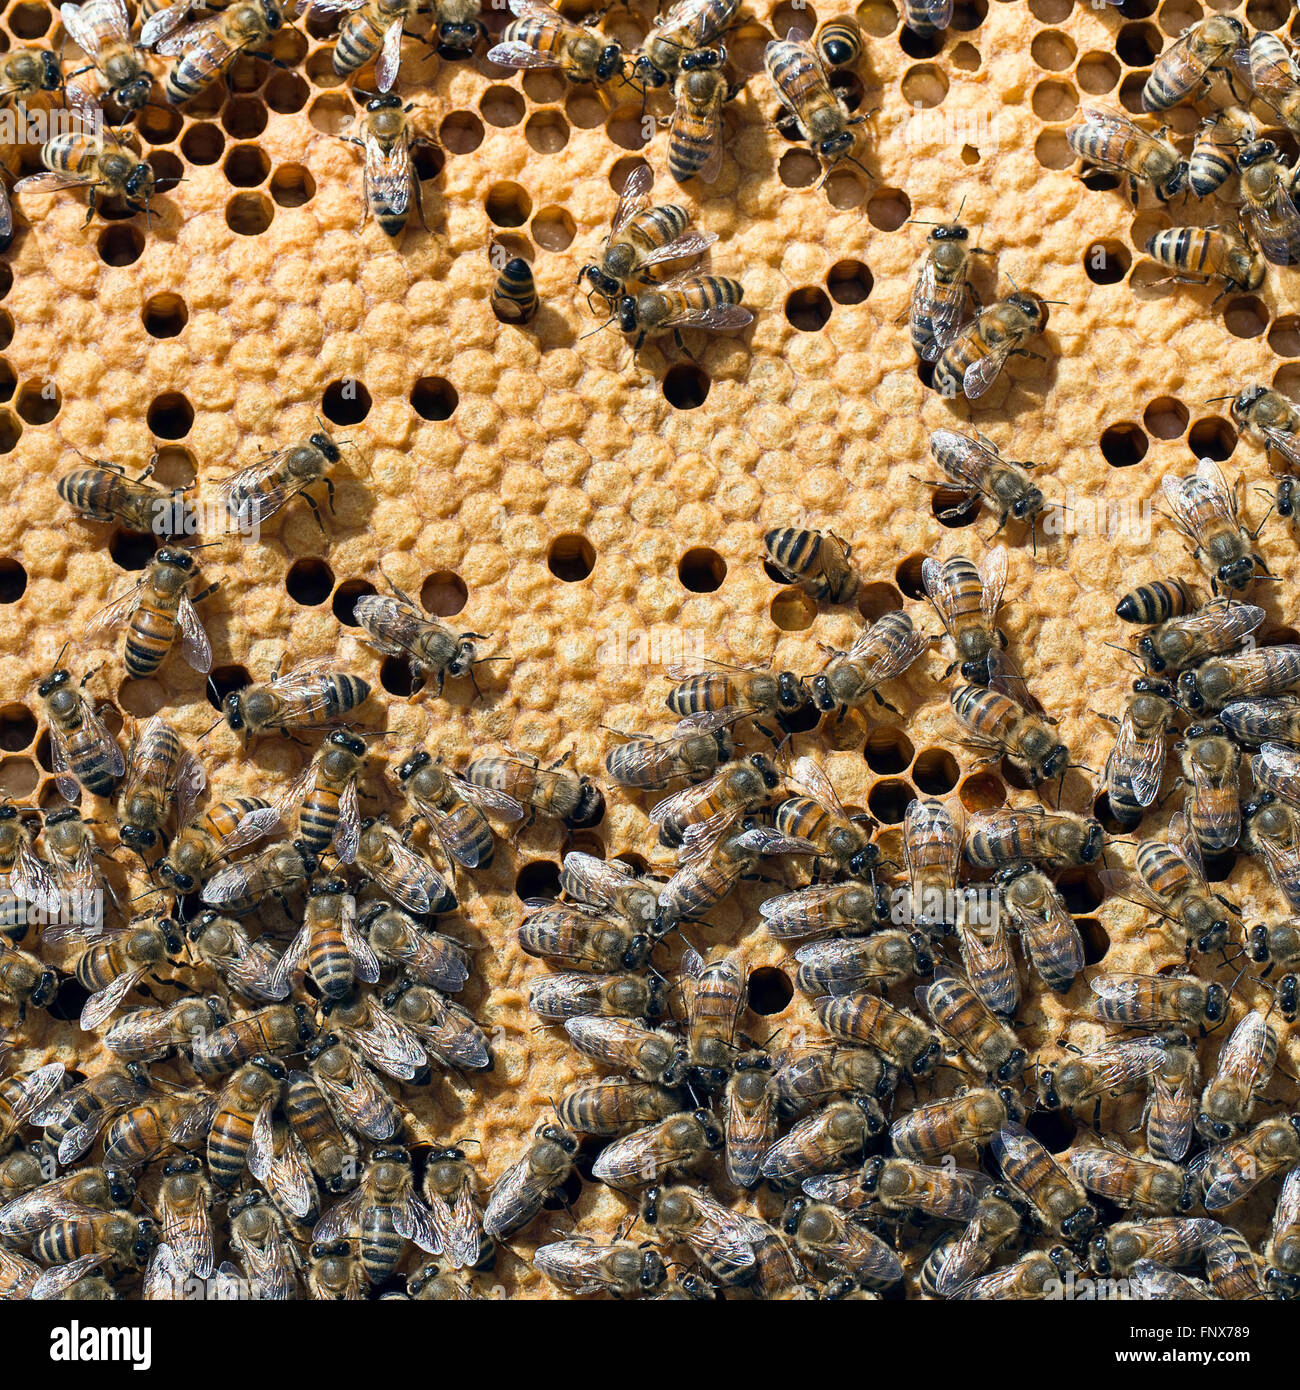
[0,0,1300,1298]
